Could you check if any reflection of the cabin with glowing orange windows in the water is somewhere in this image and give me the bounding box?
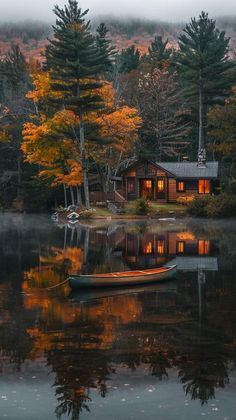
[114,231,217,270]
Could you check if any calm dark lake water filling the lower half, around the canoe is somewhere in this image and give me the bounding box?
[0,215,236,420]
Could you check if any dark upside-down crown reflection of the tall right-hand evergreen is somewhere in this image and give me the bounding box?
[176,324,231,404]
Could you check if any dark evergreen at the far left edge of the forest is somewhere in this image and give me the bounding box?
[0,45,31,206]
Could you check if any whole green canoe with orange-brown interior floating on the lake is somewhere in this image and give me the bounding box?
[68,265,177,289]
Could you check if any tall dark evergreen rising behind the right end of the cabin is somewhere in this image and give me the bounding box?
[177,12,234,156]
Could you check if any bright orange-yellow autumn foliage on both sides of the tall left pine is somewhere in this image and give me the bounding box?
[22,70,142,186]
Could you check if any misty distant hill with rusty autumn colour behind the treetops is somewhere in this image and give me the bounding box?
[0,16,236,61]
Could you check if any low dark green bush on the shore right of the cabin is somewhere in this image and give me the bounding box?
[188,194,236,217]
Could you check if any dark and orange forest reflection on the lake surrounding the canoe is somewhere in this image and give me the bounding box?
[0,217,236,420]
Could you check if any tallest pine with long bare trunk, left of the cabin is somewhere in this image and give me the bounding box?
[46,0,111,208]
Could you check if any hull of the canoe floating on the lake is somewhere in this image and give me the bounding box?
[68,265,177,289]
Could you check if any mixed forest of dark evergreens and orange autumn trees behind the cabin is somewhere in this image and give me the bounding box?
[0,0,236,212]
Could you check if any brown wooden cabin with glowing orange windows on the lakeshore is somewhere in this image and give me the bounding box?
[115,160,218,203]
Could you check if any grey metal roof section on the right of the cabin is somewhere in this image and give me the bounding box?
[156,162,218,178]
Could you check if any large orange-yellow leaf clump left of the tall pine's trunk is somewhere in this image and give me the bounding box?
[21,110,82,186]
